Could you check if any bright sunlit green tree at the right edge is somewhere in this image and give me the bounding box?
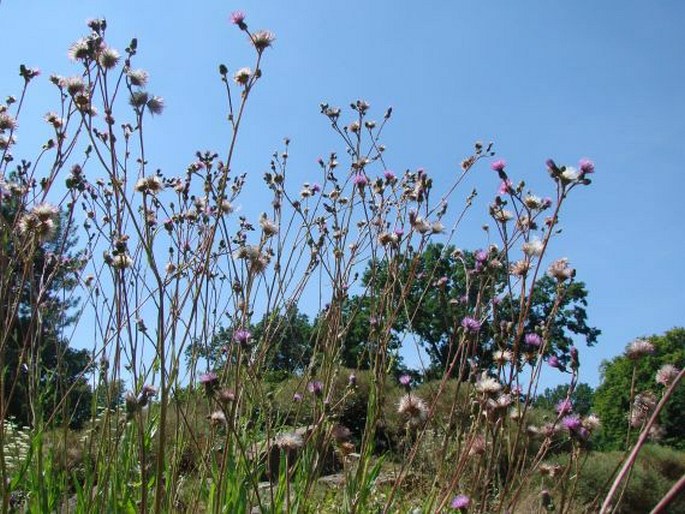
[594,328,685,449]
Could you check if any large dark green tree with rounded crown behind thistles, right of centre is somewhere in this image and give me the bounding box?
[344,244,601,375]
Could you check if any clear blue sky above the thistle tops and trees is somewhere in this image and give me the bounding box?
[0,0,685,385]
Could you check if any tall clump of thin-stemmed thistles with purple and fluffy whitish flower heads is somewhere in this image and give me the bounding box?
[0,12,682,513]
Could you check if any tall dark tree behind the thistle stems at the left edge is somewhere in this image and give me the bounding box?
[0,197,92,427]
